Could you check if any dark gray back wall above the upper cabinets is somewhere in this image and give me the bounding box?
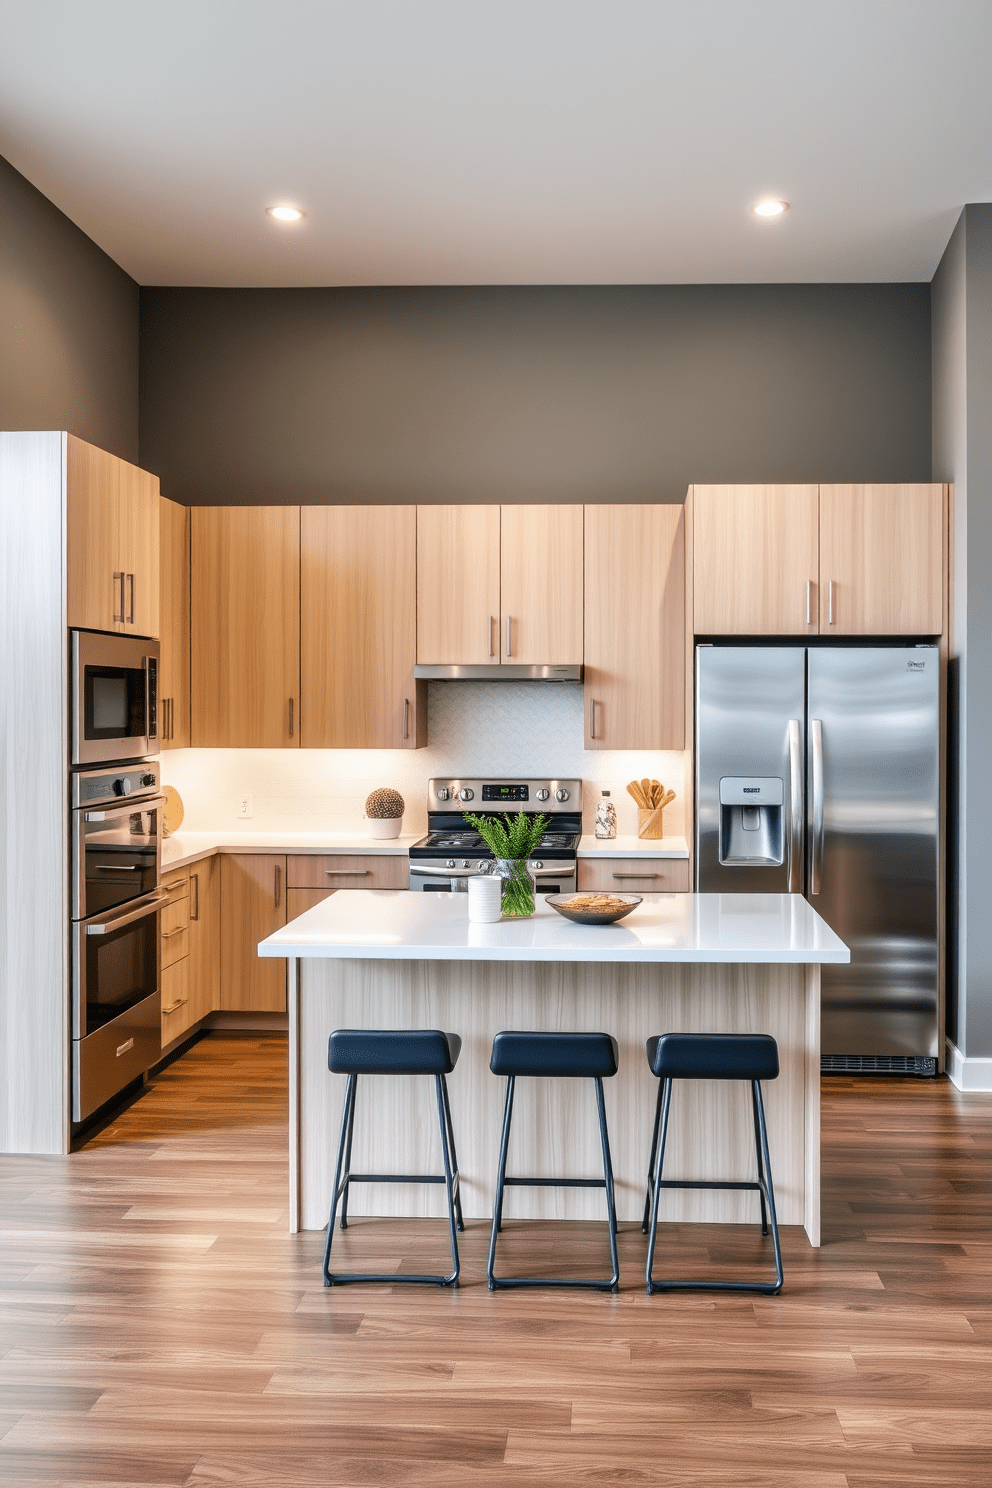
[141,284,931,504]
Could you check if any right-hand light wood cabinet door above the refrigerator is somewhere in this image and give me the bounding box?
[819,485,944,635]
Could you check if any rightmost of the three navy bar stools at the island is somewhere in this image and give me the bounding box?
[641,1033,782,1296]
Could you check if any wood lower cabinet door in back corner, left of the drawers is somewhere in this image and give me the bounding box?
[220,853,286,1013]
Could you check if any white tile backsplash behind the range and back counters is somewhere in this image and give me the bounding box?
[162,682,684,836]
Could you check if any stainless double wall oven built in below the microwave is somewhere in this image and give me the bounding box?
[71,762,165,1122]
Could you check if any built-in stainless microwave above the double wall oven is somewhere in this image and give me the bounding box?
[70,631,159,765]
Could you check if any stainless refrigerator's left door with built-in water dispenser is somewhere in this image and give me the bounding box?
[696,646,806,894]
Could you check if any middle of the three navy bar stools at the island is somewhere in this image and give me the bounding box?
[486,1033,620,1292]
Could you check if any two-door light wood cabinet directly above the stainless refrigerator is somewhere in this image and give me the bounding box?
[692,484,947,635]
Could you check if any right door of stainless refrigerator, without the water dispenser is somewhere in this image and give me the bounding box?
[808,646,940,1058]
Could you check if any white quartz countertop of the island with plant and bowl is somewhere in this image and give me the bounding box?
[259,888,851,966]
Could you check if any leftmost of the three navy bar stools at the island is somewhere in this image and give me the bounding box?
[324,1028,466,1287]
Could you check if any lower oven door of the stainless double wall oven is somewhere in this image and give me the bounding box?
[73,888,168,1039]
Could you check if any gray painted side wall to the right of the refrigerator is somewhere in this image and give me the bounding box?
[933,204,992,1059]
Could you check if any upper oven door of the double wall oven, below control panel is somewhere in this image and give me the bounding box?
[73,796,165,920]
